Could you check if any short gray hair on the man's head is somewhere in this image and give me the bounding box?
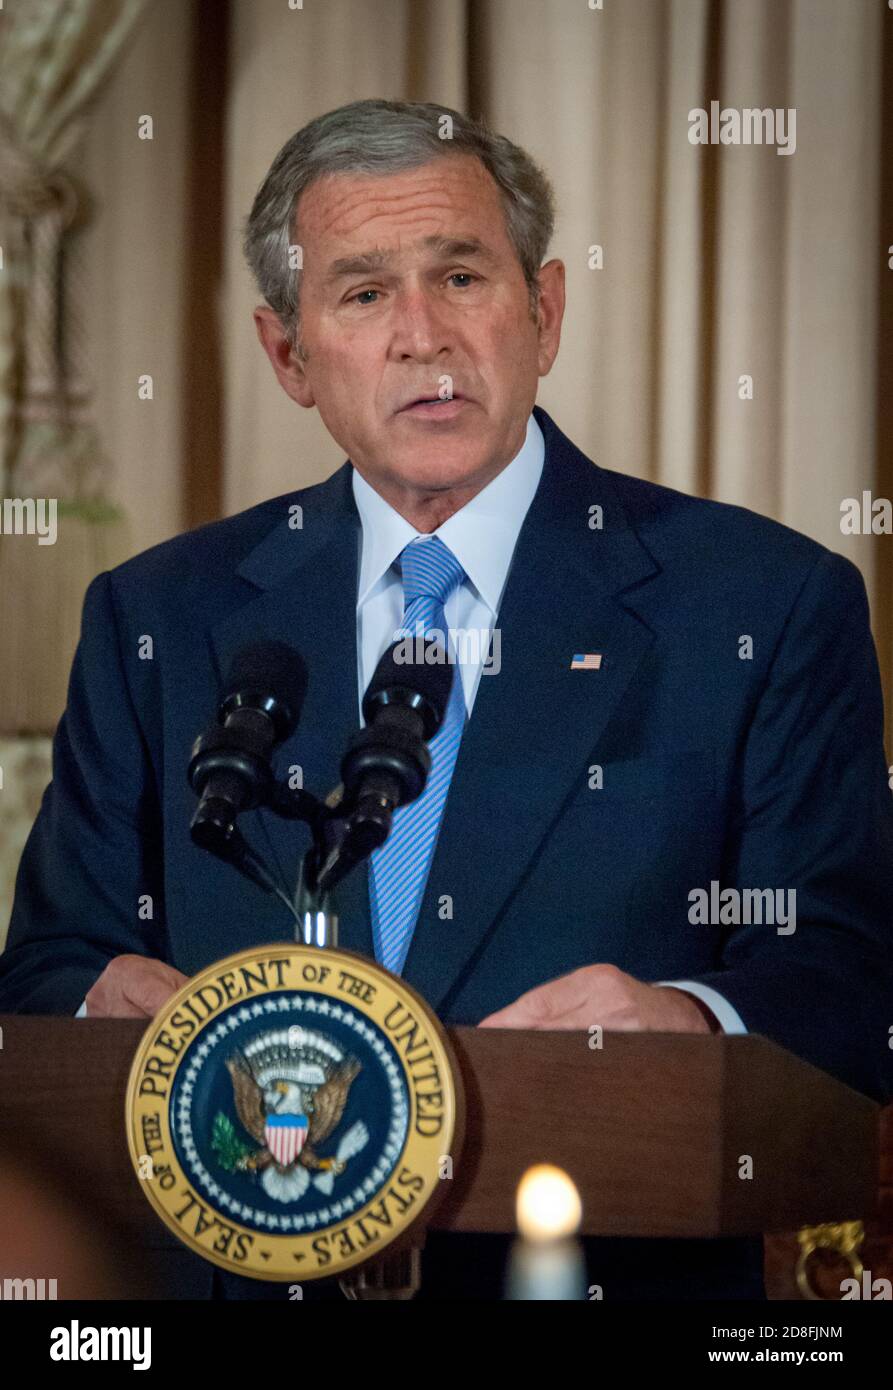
[242,99,555,352]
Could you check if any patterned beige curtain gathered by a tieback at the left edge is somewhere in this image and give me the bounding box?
[0,0,145,733]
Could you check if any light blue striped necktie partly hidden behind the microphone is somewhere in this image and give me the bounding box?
[370,535,465,974]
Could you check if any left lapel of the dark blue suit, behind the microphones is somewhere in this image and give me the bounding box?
[205,463,373,955]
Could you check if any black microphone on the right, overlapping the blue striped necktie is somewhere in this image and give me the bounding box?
[312,638,453,892]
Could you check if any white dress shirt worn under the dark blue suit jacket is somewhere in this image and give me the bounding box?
[77,414,747,1033]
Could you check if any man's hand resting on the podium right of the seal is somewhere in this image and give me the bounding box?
[478,965,711,1033]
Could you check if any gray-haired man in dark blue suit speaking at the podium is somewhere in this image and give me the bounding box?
[0,101,893,1298]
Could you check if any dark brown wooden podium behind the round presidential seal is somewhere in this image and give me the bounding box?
[0,1015,893,1297]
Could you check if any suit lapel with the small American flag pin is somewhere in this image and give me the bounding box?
[403,409,658,1009]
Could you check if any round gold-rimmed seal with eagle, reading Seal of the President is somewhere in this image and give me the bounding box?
[127,944,462,1283]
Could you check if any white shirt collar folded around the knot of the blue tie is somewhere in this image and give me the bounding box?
[352,414,545,616]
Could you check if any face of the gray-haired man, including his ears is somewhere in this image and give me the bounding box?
[256,156,563,514]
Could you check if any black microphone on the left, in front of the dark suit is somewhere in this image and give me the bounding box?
[188,641,307,853]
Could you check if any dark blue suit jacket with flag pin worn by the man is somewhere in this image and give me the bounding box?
[0,407,893,1295]
